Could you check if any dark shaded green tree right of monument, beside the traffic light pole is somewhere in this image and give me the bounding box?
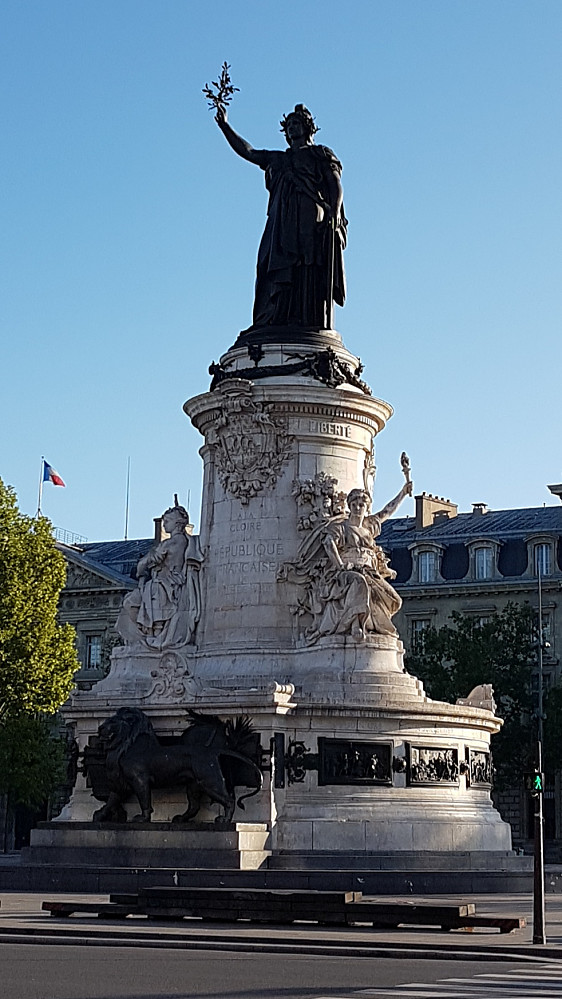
[406,603,537,788]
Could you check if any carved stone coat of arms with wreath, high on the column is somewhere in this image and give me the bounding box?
[210,381,293,506]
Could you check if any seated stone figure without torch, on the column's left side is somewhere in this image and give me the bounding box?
[115,497,201,650]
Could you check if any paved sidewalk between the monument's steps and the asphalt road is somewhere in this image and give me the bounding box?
[0,892,562,961]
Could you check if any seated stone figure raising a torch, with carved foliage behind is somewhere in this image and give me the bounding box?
[278,453,413,645]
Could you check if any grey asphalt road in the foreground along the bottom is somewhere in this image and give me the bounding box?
[0,943,540,999]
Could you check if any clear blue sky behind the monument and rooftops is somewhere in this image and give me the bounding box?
[0,0,562,540]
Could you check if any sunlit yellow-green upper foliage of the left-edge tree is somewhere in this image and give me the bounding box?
[0,479,79,721]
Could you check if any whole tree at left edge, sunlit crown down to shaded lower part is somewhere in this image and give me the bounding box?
[0,479,79,849]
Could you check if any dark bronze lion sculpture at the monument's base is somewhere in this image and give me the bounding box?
[84,708,263,824]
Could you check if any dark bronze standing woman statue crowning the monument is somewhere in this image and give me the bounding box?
[215,104,347,330]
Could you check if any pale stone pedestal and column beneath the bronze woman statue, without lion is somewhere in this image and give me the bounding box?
[41,332,511,868]
